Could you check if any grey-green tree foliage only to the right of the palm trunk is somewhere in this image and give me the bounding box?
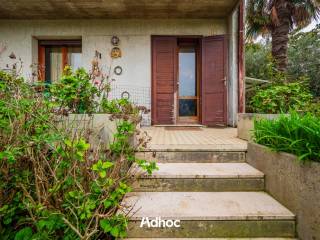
[288,25,320,97]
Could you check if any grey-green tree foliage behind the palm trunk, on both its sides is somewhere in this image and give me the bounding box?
[245,25,320,98]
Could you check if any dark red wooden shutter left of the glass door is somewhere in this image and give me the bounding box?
[152,37,177,124]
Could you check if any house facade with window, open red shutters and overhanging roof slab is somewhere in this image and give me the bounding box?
[0,0,244,126]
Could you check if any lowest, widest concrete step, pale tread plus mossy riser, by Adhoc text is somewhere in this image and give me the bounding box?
[123,192,295,238]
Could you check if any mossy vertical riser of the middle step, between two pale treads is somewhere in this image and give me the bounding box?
[133,178,264,192]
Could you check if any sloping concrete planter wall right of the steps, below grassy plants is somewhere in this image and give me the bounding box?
[247,143,320,240]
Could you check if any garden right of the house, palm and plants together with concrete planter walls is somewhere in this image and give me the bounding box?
[244,3,320,239]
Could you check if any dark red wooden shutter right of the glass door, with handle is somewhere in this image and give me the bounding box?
[201,35,227,126]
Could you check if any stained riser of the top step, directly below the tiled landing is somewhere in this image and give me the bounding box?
[136,151,246,163]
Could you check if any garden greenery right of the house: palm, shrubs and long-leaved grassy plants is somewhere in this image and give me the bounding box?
[246,1,320,162]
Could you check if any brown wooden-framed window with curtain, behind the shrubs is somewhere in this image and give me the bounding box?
[39,40,82,83]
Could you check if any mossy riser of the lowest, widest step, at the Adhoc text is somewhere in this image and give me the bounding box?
[128,220,295,238]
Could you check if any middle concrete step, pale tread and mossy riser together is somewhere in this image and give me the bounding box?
[134,163,264,192]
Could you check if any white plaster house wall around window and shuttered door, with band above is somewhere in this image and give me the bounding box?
[0,19,227,124]
